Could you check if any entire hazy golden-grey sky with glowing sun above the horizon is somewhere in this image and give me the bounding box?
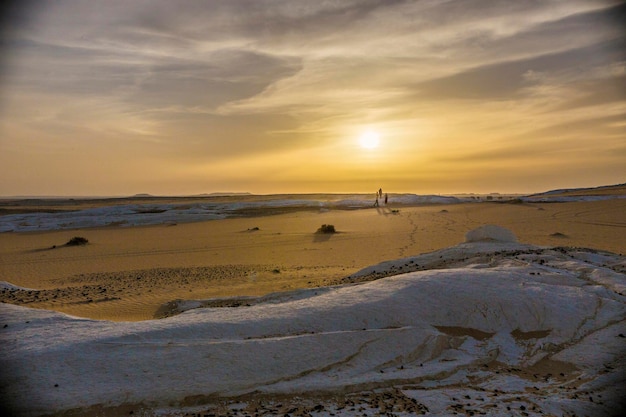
[0,0,626,196]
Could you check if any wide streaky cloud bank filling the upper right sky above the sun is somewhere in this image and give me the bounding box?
[216,2,624,121]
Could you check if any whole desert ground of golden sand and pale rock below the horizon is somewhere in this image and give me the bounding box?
[0,186,626,416]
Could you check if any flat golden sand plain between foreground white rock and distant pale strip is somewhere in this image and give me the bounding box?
[0,199,626,321]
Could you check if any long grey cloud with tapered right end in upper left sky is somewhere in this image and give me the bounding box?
[3,35,300,108]
